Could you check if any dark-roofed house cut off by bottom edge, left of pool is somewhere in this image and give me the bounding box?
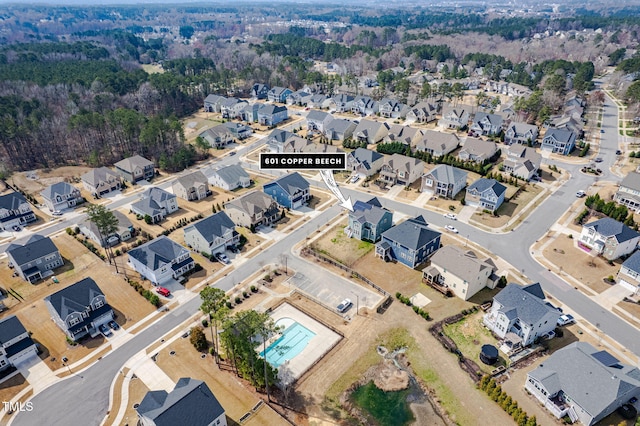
[136,377,227,426]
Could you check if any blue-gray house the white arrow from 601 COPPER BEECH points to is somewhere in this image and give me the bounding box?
[344,197,393,243]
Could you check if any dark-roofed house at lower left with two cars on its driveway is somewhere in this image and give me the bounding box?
[44,278,115,342]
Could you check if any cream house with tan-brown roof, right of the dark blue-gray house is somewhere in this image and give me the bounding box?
[422,246,500,300]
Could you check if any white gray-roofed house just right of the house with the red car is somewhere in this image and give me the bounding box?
[184,212,240,254]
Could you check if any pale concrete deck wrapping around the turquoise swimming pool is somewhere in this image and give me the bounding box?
[271,303,342,383]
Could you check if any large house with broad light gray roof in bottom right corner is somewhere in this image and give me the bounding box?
[524,342,640,426]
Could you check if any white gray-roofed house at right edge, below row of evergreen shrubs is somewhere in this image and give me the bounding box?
[578,217,640,260]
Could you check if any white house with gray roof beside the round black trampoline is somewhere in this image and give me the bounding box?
[483,283,560,352]
